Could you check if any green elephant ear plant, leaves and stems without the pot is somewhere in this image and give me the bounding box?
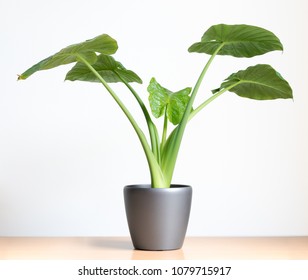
[18,24,292,188]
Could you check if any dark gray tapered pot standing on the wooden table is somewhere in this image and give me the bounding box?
[124,185,192,251]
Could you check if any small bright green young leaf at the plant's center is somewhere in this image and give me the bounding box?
[148,78,191,125]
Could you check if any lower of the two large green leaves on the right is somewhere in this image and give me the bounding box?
[213,64,293,100]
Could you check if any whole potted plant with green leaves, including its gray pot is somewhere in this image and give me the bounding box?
[18,24,292,250]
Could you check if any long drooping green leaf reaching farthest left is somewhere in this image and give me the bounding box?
[18,34,118,80]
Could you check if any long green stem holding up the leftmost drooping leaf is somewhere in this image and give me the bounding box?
[78,56,166,188]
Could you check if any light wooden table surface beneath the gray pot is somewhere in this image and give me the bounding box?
[0,237,308,260]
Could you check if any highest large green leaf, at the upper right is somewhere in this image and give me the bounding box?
[188,24,283,57]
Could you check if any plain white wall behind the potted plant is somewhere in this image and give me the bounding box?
[0,0,308,236]
